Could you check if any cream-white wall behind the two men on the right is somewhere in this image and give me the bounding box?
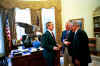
[61,0,100,37]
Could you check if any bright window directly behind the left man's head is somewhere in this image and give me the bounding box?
[42,8,56,36]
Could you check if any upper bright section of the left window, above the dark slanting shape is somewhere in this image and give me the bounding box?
[15,8,31,24]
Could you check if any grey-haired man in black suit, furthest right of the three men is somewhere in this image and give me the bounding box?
[71,22,91,66]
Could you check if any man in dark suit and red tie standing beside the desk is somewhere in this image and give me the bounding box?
[41,22,60,66]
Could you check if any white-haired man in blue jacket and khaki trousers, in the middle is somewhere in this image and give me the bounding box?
[61,21,73,66]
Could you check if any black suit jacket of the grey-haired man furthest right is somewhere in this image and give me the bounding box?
[71,29,91,63]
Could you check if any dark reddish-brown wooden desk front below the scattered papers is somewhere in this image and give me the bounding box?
[12,51,60,66]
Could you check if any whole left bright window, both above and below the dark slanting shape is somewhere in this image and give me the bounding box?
[15,8,31,40]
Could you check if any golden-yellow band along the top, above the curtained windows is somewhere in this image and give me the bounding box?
[0,0,57,8]
